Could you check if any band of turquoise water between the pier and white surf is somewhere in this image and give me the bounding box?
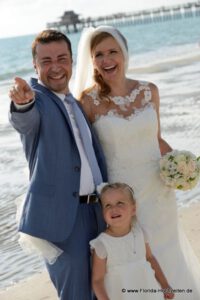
[0,17,200,80]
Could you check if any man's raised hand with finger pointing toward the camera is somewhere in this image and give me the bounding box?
[9,77,35,105]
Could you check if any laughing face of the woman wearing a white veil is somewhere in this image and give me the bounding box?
[92,37,125,83]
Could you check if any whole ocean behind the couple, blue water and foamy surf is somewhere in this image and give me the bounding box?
[0,17,200,289]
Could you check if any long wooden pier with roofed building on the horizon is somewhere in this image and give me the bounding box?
[47,0,200,33]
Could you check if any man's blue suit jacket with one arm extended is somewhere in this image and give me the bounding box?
[10,79,107,242]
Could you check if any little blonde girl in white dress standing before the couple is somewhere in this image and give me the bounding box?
[90,183,174,300]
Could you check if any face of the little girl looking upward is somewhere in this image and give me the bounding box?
[101,189,135,228]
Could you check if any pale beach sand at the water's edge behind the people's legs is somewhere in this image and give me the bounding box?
[0,203,200,300]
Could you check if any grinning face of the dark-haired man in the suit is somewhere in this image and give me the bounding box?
[33,41,72,94]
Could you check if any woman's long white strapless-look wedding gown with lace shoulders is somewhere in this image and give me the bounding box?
[88,82,200,300]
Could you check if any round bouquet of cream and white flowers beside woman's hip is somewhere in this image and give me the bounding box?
[160,150,200,191]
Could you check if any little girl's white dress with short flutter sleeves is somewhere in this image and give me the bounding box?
[90,223,164,300]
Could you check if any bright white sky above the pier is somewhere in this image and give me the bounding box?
[0,0,197,38]
